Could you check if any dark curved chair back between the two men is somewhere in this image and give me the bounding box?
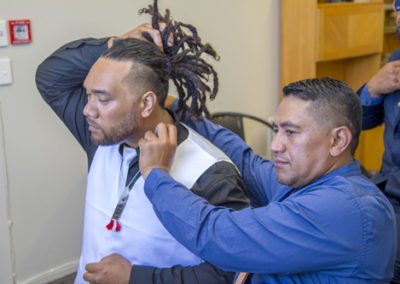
[210,112,273,158]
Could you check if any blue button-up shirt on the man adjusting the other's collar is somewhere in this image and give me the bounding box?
[145,118,396,283]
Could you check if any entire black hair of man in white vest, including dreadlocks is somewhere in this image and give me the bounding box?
[102,0,219,120]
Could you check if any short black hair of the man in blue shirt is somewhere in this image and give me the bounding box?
[283,78,362,155]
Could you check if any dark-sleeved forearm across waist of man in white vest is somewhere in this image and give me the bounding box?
[129,262,234,284]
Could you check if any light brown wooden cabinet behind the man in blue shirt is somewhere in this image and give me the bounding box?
[280,0,385,171]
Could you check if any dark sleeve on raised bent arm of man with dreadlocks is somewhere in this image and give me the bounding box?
[36,38,108,159]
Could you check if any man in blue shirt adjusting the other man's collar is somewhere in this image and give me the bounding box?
[139,78,396,283]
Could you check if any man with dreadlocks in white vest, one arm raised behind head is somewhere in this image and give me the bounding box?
[36,3,248,284]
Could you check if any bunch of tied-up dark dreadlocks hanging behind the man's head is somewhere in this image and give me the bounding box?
[139,0,219,120]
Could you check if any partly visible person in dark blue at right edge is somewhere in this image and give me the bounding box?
[358,0,400,283]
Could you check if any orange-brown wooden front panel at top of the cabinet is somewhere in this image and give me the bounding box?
[316,3,384,61]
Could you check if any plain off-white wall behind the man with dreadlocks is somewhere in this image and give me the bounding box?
[0,0,279,283]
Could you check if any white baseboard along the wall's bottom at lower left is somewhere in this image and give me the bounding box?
[16,260,79,284]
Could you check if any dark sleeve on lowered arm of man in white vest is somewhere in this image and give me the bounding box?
[129,161,249,284]
